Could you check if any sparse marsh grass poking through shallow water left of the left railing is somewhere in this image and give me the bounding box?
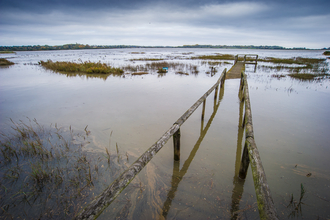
[0,119,128,219]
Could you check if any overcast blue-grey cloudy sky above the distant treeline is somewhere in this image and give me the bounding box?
[0,0,330,48]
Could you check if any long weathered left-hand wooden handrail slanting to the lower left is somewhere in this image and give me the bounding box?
[74,69,226,220]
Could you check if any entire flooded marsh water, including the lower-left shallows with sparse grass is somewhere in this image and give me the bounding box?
[0,48,330,219]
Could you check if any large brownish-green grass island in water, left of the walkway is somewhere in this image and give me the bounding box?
[39,60,124,75]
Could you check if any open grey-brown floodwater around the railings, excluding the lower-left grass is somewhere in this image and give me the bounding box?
[0,48,330,219]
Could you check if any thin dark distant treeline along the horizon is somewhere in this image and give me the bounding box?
[0,43,330,51]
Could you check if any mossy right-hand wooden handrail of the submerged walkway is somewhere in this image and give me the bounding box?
[240,72,278,219]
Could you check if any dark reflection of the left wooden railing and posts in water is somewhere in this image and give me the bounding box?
[162,81,225,219]
